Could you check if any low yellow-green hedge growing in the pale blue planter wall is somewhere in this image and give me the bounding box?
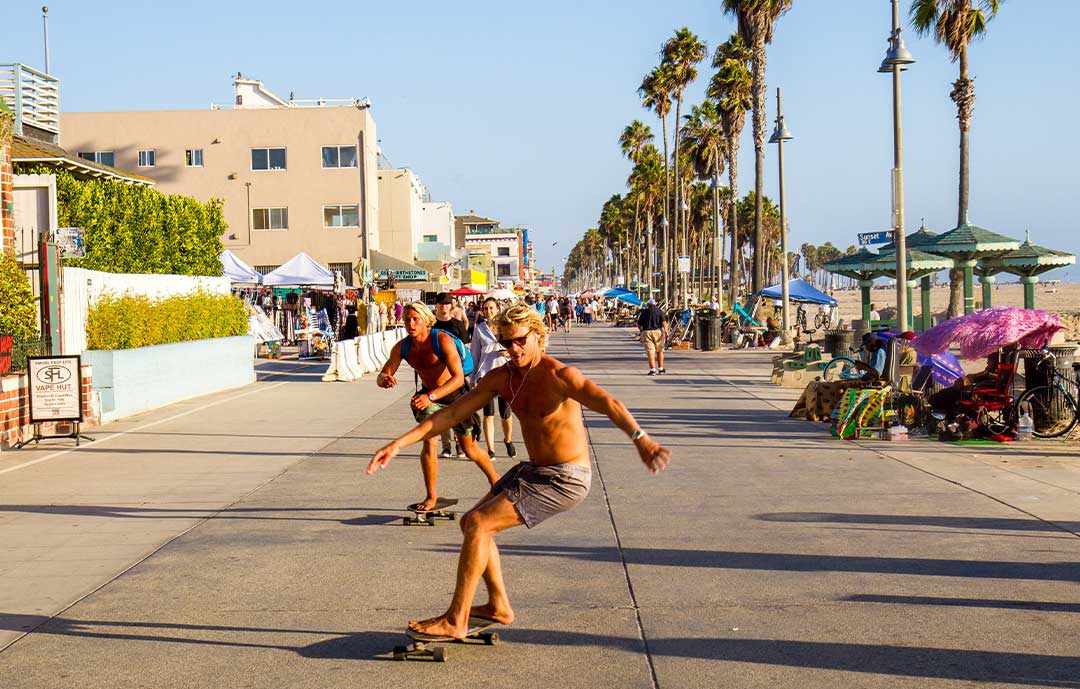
[86,293,247,350]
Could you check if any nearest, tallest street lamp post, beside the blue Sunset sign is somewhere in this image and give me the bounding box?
[878,0,915,329]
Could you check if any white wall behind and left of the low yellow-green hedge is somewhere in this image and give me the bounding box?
[60,268,230,354]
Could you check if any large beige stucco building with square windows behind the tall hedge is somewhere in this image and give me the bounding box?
[62,76,380,283]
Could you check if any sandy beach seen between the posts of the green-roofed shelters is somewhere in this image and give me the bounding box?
[833,282,1080,341]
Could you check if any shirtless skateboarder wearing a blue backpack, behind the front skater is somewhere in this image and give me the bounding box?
[377,302,499,510]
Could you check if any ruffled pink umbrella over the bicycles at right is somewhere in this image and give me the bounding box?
[912,307,1065,359]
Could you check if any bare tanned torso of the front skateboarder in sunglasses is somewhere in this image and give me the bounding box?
[481,352,590,468]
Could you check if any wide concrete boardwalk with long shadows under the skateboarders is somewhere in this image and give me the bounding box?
[0,326,1080,689]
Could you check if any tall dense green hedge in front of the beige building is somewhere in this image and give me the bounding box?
[16,164,228,275]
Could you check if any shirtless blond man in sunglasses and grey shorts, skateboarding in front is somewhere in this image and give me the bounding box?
[367,305,671,638]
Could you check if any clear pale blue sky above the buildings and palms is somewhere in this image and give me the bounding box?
[8,0,1080,280]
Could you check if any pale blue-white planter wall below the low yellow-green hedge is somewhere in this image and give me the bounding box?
[82,335,255,423]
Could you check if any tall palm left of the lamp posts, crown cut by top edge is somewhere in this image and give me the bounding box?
[724,0,792,293]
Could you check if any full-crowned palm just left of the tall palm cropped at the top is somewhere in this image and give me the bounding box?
[707,33,753,305]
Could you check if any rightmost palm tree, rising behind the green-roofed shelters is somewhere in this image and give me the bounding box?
[910,0,1002,319]
